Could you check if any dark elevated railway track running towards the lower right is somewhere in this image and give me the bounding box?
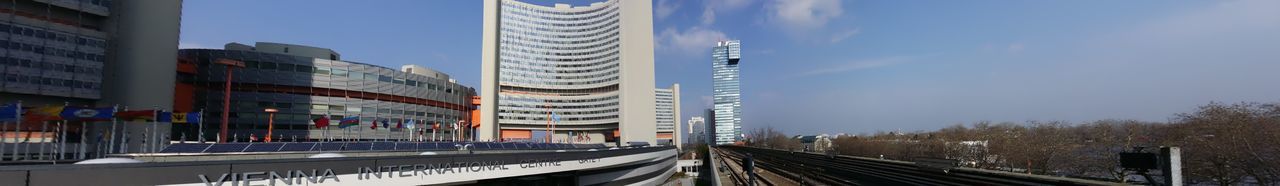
[717,146,1123,186]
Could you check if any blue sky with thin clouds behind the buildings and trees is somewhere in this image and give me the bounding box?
[179,0,1280,135]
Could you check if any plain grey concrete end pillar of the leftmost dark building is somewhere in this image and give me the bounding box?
[97,0,182,151]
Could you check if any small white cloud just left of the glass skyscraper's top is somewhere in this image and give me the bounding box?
[657,27,728,55]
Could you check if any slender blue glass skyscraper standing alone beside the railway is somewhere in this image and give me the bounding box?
[712,40,742,145]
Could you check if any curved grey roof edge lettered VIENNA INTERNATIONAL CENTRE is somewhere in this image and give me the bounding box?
[0,146,677,186]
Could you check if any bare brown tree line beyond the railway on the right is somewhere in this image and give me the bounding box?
[748,103,1280,185]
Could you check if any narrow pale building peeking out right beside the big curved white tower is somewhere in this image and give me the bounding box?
[654,83,684,148]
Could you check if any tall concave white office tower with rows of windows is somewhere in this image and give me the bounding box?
[477,0,657,144]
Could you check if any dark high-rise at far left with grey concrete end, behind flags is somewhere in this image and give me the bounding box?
[0,0,182,151]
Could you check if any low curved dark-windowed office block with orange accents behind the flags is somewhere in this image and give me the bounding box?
[174,42,475,141]
